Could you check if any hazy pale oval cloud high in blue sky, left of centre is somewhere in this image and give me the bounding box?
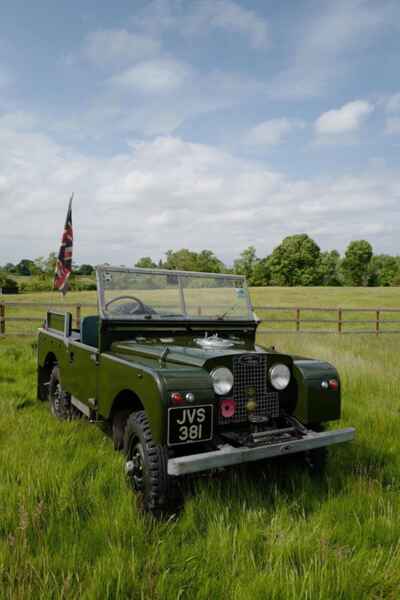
[109,59,190,94]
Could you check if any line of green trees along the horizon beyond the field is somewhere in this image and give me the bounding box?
[0,234,400,291]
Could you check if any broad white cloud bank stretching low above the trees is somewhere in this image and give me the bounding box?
[0,117,400,265]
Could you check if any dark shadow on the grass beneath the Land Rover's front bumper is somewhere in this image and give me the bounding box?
[180,444,392,515]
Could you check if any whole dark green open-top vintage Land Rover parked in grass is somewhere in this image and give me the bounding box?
[38,266,355,515]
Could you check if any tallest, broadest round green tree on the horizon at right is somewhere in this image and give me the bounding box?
[268,233,321,286]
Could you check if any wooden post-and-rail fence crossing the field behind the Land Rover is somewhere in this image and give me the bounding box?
[0,301,400,336]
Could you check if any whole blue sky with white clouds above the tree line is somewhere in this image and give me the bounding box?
[0,0,400,265]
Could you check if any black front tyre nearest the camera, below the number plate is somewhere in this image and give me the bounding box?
[124,411,178,518]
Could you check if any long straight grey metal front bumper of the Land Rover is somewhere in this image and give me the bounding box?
[168,427,355,476]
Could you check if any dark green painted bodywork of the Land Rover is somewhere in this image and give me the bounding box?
[38,270,340,447]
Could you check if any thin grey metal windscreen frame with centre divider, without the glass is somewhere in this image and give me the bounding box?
[96,265,257,323]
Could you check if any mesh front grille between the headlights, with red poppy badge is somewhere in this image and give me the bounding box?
[218,354,279,425]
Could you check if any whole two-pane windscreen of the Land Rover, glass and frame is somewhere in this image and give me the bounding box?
[97,266,254,320]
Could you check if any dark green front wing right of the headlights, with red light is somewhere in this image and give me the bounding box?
[293,359,341,425]
